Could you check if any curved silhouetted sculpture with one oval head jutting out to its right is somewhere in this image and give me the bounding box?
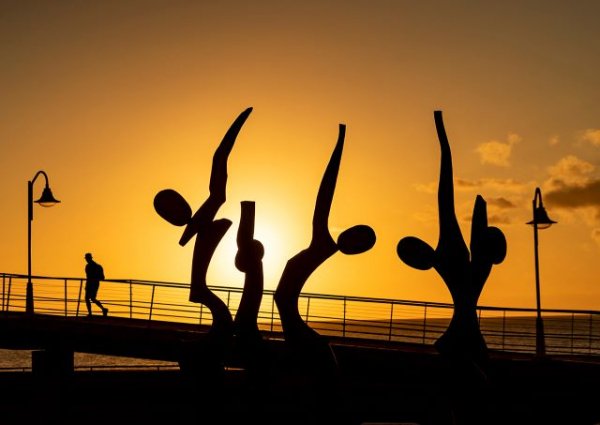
[275,124,375,376]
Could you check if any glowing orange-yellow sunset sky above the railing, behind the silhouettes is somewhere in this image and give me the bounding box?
[0,0,600,309]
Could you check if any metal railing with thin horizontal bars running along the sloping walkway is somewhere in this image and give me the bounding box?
[1,273,600,357]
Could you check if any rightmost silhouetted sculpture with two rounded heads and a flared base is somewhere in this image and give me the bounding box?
[397,111,506,365]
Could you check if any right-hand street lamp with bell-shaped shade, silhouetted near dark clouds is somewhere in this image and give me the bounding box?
[527,187,556,357]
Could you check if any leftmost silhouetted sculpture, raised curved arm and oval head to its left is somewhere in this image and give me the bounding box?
[154,108,252,374]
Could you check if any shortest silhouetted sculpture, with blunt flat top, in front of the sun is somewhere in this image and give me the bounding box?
[234,201,266,369]
